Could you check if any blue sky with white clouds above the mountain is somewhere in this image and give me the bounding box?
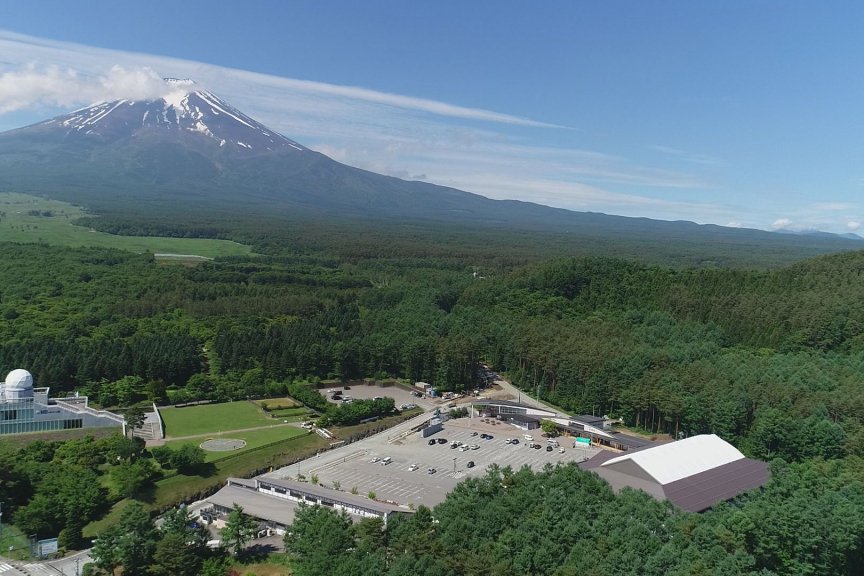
[0,0,864,232]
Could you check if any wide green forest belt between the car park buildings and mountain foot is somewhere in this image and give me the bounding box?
[0,244,864,460]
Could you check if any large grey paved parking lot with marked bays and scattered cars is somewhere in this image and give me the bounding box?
[267,414,598,506]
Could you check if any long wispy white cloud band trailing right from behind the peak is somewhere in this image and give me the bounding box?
[0,31,732,224]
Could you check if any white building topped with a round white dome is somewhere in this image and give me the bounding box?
[0,368,125,435]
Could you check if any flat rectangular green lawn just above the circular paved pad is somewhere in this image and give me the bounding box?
[159,400,274,436]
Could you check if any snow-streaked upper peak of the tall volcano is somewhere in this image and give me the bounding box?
[42,78,306,153]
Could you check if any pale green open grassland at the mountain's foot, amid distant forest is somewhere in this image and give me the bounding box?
[0,192,252,258]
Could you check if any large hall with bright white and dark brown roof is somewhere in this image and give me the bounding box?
[580,434,770,512]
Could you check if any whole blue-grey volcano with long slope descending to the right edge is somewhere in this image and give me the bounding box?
[0,79,861,264]
